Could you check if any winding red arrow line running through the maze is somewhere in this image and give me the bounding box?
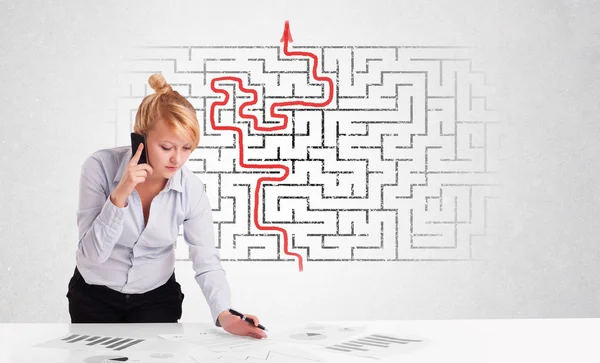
[210,21,333,271]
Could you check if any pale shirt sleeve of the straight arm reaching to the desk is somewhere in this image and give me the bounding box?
[183,184,231,327]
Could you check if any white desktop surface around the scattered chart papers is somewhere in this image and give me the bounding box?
[0,319,600,363]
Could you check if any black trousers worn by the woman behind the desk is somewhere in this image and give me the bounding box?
[67,267,185,323]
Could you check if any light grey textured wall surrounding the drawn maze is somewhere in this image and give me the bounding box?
[0,1,600,322]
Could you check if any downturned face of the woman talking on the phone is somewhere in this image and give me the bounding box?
[146,120,192,181]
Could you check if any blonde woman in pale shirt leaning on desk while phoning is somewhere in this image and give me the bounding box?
[67,74,266,338]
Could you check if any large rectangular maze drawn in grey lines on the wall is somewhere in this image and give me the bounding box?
[114,37,500,270]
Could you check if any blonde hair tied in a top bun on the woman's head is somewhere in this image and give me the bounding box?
[133,73,200,149]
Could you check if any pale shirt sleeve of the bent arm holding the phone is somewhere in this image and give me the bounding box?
[77,157,129,263]
